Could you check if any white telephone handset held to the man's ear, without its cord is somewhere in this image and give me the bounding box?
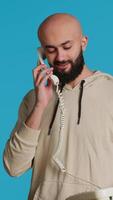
[37,47,59,85]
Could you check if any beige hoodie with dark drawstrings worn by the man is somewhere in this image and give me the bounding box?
[4,71,113,200]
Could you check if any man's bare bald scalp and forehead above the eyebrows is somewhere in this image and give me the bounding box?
[38,13,82,44]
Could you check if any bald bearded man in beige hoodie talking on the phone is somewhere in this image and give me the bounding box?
[4,13,113,200]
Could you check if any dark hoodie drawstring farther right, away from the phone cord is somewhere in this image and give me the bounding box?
[77,80,85,124]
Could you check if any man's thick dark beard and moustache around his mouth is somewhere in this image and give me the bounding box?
[49,49,85,86]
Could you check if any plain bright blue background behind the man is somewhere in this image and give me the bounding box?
[0,0,113,200]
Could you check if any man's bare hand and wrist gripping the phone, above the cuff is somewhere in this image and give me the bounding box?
[25,65,53,129]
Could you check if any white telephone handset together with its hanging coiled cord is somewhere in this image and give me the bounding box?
[38,47,64,171]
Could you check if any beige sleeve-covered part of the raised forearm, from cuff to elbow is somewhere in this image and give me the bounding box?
[4,124,40,176]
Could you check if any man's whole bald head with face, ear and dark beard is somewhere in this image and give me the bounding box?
[38,13,87,83]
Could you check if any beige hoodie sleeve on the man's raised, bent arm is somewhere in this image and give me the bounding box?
[3,90,40,176]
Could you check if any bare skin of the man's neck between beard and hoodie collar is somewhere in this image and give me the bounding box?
[69,65,94,88]
